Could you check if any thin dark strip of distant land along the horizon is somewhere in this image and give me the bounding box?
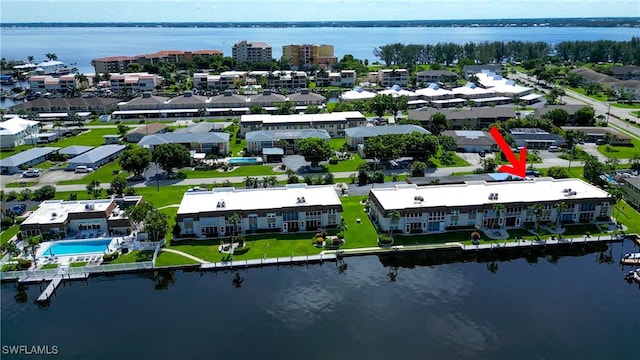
[0,17,640,28]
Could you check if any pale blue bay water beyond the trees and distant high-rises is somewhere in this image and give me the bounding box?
[0,27,640,72]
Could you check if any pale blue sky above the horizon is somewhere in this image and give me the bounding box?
[0,0,640,23]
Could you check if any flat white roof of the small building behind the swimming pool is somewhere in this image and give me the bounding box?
[22,199,113,225]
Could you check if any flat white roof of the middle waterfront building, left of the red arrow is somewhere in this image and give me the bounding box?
[178,184,341,214]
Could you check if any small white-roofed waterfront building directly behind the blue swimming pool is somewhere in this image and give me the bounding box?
[20,196,143,240]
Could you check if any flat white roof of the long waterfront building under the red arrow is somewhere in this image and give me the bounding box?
[371,178,609,210]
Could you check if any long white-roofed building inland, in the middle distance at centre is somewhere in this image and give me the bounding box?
[240,111,367,137]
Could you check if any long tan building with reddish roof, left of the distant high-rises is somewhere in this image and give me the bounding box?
[91,50,223,73]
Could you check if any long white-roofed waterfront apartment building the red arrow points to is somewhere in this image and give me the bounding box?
[369,178,614,234]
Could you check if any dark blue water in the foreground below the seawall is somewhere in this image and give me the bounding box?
[2,242,640,359]
